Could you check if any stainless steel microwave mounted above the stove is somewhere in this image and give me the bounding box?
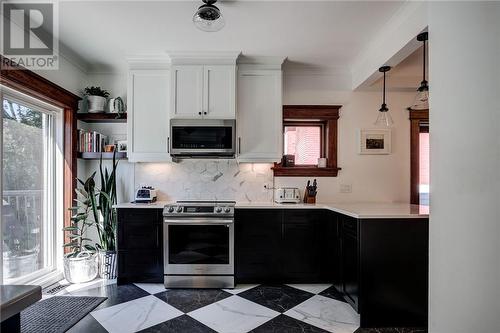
[169,119,236,158]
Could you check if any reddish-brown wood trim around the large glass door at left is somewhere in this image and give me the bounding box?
[0,55,81,245]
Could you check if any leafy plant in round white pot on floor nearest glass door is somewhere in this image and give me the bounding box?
[63,172,98,283]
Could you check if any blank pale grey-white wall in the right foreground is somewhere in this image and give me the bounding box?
[429,2,500,333]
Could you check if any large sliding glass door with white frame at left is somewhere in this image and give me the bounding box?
[1,88,62,284]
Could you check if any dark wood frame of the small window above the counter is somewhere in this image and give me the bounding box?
[273,105,342,177]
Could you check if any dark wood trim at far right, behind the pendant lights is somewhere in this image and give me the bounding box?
[409,110,429,205]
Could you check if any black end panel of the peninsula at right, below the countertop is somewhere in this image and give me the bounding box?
[358,218,429,327]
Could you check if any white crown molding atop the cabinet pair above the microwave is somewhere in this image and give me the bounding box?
[167,51,241,65]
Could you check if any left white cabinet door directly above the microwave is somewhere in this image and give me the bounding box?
[171,65,204,119]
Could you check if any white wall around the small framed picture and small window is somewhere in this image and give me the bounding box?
[282,75,414,202]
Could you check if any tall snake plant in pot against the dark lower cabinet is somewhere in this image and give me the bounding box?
[92,152,118,279]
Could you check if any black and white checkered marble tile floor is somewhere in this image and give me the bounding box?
[45,280,423,333]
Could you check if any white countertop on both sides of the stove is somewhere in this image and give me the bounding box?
[115,201,429,219]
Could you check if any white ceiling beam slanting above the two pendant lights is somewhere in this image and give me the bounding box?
[351,1,427,90]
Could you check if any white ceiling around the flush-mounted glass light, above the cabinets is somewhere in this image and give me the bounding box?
[59,0,404,73]
